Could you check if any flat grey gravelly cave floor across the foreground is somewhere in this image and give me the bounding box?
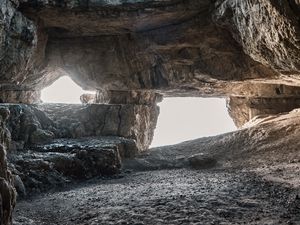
[14,169,300,225]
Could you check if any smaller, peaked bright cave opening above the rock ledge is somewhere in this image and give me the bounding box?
[41,76,95,104]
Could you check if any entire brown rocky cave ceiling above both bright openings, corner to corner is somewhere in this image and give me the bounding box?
[0,0,300,98]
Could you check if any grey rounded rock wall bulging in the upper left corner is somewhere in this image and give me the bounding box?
[0,0,47,91]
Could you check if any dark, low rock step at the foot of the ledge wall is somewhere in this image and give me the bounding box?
[9,137,136,196]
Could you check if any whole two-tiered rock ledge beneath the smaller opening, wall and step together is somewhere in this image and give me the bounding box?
[1,102,158,196]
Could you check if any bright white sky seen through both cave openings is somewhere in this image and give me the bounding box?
[41,76,236,147]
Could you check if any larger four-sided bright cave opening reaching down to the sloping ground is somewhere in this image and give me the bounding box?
[151,97,236,147]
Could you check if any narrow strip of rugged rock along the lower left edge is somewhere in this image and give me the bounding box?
[0,108,16,225]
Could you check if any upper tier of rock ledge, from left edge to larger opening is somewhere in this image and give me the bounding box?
[2,104,159,151]
